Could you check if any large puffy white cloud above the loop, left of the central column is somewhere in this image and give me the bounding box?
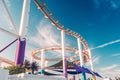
[31,19,60,48]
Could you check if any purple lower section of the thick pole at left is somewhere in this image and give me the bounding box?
[15,39,26,65]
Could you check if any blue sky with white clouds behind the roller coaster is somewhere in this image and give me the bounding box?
[0,0,120,75]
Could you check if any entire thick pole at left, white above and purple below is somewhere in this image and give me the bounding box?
[15,0,31,65]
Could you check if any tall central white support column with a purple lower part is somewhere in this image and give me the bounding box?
[61,30,67,78]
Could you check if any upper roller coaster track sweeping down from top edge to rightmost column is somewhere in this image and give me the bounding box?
[34,0,88,49]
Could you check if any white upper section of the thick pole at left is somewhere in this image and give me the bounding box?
[19,0,30,39]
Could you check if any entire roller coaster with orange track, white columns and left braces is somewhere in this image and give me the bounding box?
[0,0,101,80]
